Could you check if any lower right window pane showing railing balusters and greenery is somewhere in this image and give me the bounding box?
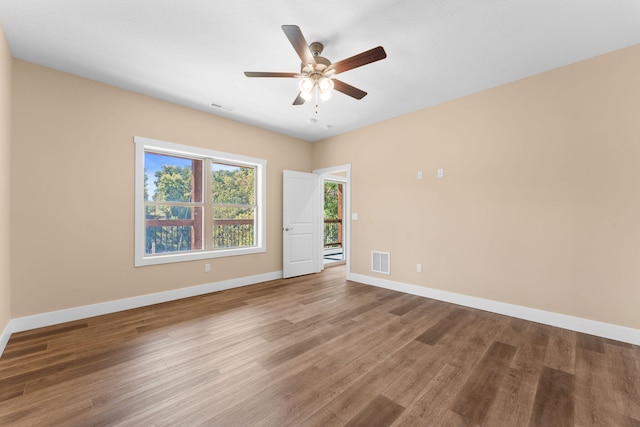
[213,207,255,249]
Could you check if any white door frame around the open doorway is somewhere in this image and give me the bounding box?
[312,163,351,280]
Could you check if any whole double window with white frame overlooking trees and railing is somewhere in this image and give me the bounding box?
[134,137,266,266]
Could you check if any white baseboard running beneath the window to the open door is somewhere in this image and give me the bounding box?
[0,271,282,355]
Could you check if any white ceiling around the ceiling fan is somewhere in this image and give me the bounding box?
[0,0,640,141]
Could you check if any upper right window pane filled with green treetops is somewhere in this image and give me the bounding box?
[211,163,255,205]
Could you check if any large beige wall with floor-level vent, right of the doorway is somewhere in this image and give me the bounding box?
[313,45,640,328]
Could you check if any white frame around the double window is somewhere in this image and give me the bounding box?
[133,136,267,267]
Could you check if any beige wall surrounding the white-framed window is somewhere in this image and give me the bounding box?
[11,60,311,318]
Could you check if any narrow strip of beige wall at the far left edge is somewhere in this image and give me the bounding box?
[0,26,13,333]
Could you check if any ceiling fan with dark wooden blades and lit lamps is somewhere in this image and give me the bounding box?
[244,25,387,105]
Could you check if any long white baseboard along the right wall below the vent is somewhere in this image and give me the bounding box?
[348,273,640,345]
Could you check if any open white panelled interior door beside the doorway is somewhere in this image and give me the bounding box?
[282,170,320,278]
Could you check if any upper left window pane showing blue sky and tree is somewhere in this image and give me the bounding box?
[144,152,202,202]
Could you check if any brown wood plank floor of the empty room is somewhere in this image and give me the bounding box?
[0,266,640,427]
